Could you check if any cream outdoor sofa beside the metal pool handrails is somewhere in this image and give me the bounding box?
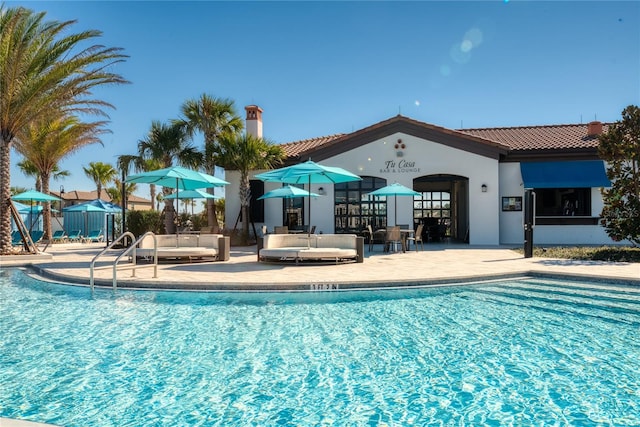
[136,234,230,261]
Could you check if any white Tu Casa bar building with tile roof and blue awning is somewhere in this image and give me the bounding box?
[226,110,614,245]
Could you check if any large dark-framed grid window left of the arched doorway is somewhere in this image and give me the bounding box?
[334,177,387,233]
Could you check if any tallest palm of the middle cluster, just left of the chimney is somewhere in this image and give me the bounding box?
[175,94,244,231]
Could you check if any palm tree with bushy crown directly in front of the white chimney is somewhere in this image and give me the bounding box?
[216,134,284,244]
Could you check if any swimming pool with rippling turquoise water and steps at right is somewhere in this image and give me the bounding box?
[0,269,640,427]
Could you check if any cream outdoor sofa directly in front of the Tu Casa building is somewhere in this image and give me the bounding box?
[258,234,364,263]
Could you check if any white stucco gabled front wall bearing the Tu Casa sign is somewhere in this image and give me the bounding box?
[225,133,499,245]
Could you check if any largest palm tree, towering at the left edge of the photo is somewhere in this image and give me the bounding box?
[0,3,127,254]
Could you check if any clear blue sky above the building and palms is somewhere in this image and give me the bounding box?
[5,0,640,196]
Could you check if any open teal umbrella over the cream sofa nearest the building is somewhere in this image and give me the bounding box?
[256,160,362,237]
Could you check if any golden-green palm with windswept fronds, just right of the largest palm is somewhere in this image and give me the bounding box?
[15,116,109,240]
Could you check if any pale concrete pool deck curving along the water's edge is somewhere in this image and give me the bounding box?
[0,243,640,291]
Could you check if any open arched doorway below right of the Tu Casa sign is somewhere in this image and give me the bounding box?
[413,174,469,243]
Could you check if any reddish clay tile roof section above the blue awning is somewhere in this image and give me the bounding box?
[459,123,609,151]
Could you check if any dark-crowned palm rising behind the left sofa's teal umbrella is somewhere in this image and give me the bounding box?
[138,121,202,233]
